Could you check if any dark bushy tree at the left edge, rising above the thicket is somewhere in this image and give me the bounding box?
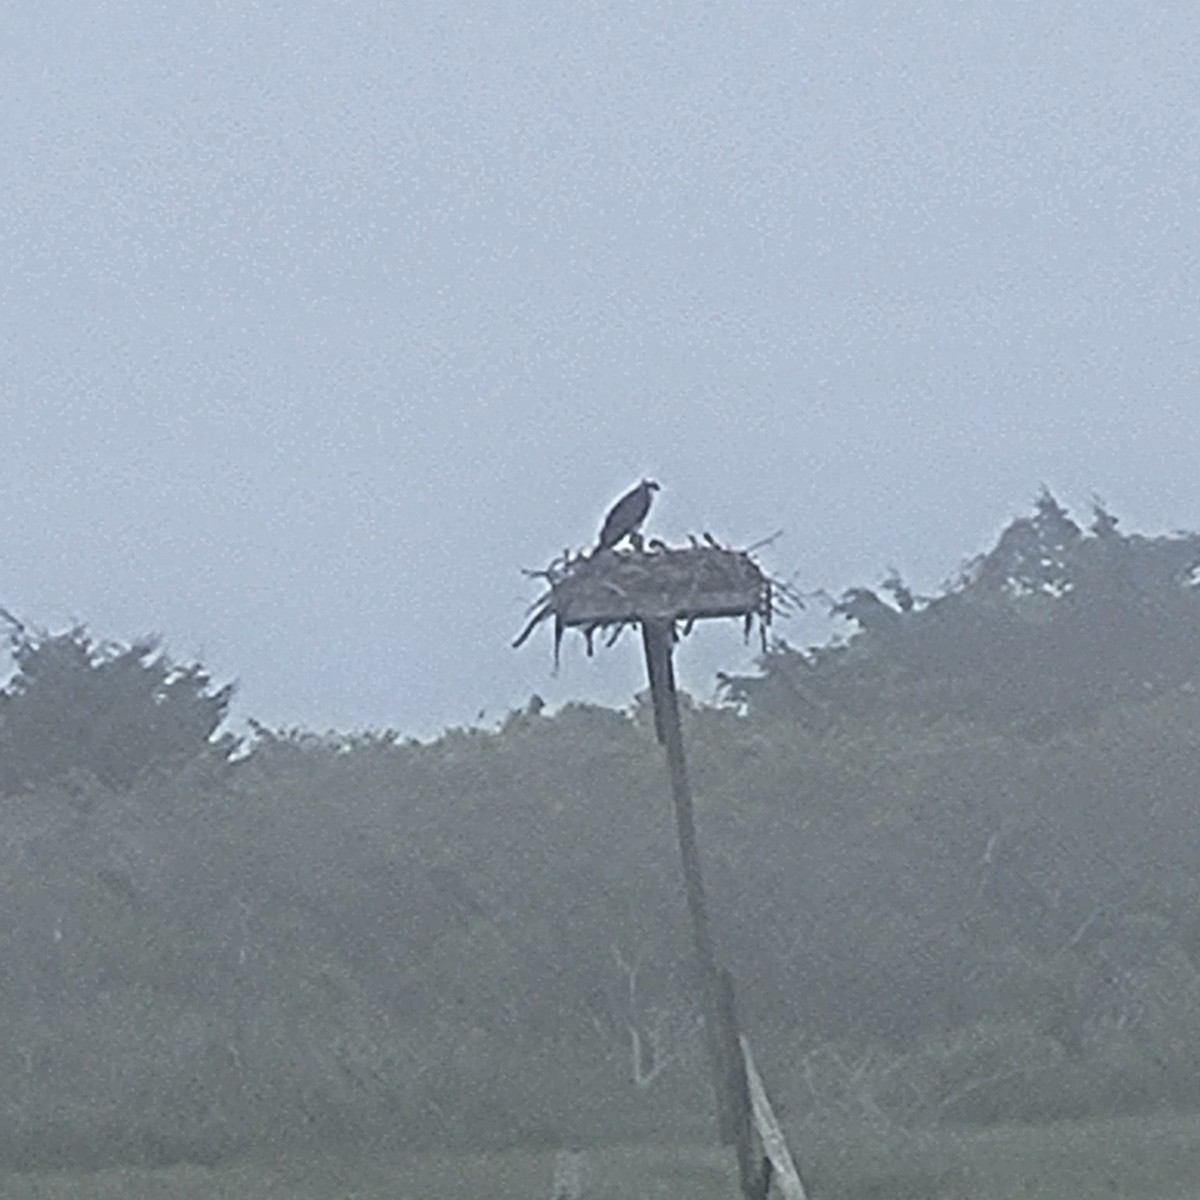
[0,613,234,794]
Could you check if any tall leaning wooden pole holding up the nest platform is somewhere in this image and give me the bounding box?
[642,620,767,1196]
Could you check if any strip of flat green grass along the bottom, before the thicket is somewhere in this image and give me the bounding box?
[7,1117,1200,1200]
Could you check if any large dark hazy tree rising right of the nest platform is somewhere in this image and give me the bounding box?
[722,491,1200,736]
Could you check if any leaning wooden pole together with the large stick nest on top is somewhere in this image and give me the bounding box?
[514,544,773,1200]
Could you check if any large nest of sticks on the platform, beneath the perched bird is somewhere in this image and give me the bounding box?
[512,541,786,666]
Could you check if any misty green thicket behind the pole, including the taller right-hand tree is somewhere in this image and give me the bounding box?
[0,498,1200,1160]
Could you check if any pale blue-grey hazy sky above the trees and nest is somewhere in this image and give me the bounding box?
[0,0,1200,737]
